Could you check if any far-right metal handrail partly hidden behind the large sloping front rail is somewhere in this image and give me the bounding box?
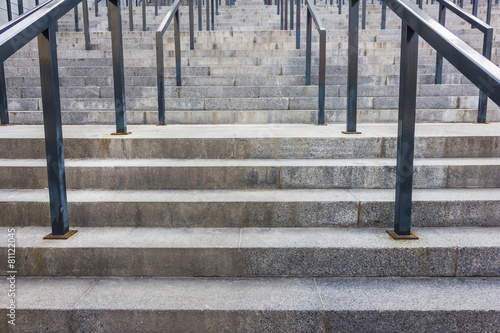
[434,0,493,123]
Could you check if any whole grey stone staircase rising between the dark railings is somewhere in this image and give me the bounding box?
[0,0,500,332]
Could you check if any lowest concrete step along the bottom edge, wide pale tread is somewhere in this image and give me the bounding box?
[0,277,500,333]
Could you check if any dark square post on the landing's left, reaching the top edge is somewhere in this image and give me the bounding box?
[108,0,128,134]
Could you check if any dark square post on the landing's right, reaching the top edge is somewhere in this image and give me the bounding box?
[343,0,359,134]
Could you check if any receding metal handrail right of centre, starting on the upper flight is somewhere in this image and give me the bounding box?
[296,0,326,125]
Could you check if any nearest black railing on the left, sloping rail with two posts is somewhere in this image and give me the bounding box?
[0,0,127,239]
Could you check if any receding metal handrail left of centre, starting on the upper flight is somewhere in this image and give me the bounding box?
[155,0,195,125]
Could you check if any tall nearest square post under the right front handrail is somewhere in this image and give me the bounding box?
[394,20,418,236]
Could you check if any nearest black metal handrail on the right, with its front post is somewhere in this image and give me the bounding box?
[378,0,500,238]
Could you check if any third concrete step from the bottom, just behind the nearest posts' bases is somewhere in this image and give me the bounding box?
[0,188,500,228]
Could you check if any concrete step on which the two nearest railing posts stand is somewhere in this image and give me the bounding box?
[0,227,500,276]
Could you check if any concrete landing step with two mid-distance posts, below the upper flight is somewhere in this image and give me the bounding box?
[0,123,500,159]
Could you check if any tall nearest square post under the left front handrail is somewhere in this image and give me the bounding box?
[38,21,69,236]
